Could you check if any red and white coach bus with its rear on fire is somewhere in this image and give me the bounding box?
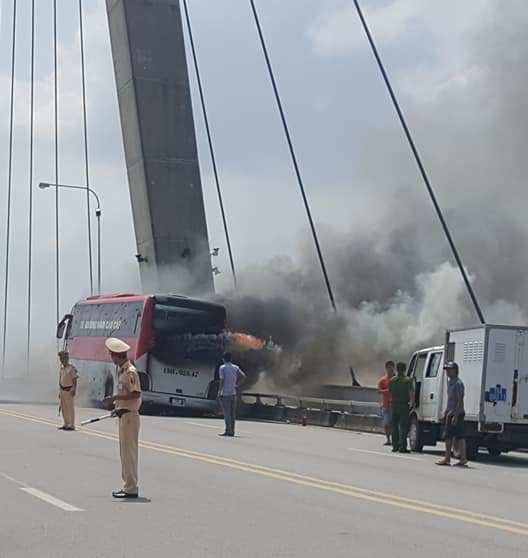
[57,294,226,412]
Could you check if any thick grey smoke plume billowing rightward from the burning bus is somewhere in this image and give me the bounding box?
[216,1,528,391]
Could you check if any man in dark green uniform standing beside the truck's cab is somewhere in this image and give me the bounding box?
[389,362,413,453]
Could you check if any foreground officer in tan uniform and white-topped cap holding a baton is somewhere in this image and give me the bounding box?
[105,337,141,498]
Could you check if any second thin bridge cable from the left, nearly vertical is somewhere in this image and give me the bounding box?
[26,0,35,375]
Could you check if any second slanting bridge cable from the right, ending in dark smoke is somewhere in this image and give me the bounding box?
[249,0,337,312]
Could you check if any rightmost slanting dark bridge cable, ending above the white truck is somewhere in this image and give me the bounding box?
[354,0,486,324]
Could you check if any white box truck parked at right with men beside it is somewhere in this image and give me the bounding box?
[407,325,528,459]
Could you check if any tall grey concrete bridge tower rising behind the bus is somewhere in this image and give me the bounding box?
[106,0,213,295]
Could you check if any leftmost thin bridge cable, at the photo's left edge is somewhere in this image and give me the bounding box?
[2,0,17,378]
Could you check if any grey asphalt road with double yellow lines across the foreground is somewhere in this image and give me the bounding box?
[0,404,528,558]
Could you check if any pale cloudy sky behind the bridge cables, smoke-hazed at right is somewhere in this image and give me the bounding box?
[0,0,528,380]
